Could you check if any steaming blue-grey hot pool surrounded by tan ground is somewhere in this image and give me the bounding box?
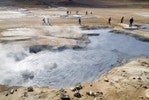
[0,29,149,87]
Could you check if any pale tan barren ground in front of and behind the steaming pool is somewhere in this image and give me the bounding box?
[0,5,149,100]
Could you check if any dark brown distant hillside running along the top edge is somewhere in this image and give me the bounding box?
[0,0,149,8]
